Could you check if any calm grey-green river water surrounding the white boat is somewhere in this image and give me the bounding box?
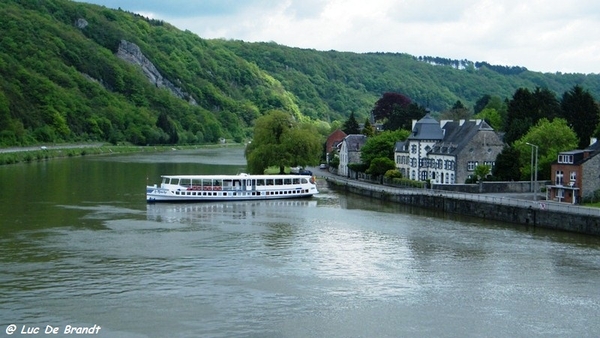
[0,148,600,337]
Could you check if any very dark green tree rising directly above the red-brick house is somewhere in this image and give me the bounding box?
[561,85,600,149]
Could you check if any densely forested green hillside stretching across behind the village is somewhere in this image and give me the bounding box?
[0,0,600,146]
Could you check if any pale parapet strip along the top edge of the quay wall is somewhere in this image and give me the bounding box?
[322,175,600,217]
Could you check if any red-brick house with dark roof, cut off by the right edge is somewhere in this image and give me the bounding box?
[546,139,600,204]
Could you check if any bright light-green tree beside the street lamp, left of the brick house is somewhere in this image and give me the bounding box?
[514,118,577,180]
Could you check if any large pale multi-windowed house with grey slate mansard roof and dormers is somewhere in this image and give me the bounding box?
[394,114,504,184]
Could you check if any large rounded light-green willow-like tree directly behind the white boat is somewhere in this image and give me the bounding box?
[245,110,322,174]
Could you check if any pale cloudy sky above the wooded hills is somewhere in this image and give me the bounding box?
[77,0,600,74]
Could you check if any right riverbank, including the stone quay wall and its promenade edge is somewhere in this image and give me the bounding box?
[318,172,600,236]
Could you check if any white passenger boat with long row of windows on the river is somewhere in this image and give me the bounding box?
[146,174,319,203]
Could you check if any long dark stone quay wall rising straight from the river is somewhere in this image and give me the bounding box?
[327,178,600,236]
